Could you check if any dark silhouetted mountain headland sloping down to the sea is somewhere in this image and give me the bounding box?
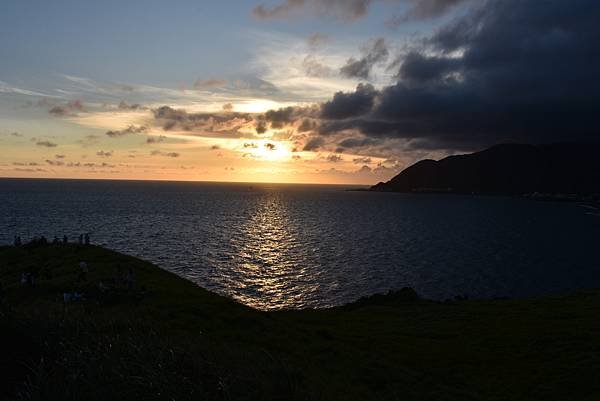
[371,143,600,194]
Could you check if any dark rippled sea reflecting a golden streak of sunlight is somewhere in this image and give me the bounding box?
[0,180,600,309]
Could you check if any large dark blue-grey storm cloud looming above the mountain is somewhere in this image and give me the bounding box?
[319,0,600,150]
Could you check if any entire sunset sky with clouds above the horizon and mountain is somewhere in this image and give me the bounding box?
[0,0,600,184]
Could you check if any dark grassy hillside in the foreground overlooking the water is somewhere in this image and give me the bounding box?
[0,244,600,401]
